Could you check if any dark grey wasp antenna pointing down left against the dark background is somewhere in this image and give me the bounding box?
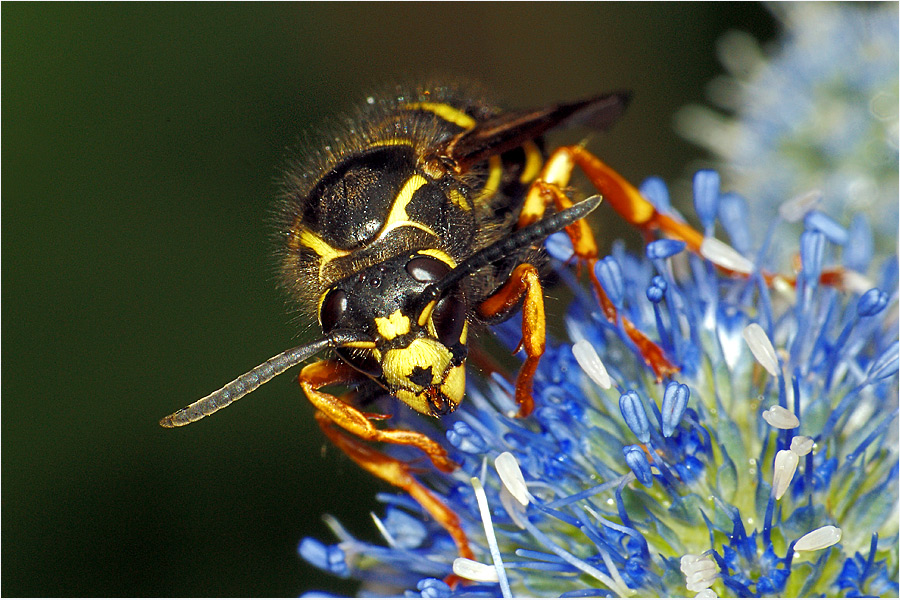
[159,330,369,427]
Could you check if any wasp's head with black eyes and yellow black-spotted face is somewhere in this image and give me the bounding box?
[319,249,467,416]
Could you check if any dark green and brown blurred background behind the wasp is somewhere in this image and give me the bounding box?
[0,3,775,596]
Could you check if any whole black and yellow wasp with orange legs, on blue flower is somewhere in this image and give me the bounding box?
[160,86,684,558]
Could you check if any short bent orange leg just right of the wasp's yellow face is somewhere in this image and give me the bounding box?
[478,263,546,417]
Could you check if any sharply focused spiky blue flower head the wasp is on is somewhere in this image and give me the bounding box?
[300,165,898,597]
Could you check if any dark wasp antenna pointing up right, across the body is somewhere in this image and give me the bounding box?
[420,195,603,302]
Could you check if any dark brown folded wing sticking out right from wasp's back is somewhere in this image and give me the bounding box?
[442,92,631,173]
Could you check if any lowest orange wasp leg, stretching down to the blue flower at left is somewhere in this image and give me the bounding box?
[316,411,475,560]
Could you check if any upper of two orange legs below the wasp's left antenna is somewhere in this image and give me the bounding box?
[298,359,458,476]
